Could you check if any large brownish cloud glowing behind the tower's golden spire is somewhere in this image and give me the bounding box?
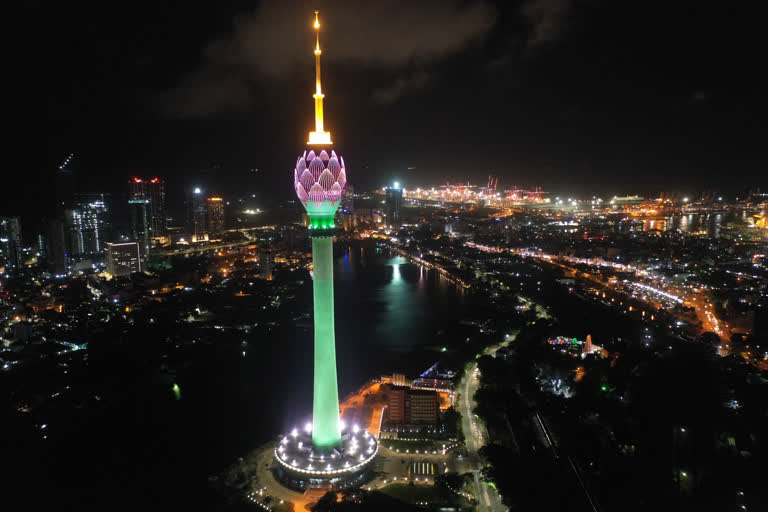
[158,0,495,118]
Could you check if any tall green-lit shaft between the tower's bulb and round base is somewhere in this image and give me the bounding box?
[312,237,341,451]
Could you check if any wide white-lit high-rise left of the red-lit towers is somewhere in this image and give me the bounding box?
[64,194,110,257]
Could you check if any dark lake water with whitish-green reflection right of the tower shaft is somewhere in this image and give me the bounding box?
[334,247,466,391]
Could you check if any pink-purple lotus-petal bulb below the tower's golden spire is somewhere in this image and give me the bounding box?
[293,150,347,213]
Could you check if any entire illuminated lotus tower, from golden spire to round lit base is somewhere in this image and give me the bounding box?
[275,12,378,488]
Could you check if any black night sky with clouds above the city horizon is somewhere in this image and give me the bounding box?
[31,0,768,215]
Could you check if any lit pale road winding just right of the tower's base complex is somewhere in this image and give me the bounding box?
[456,336,514,512]
